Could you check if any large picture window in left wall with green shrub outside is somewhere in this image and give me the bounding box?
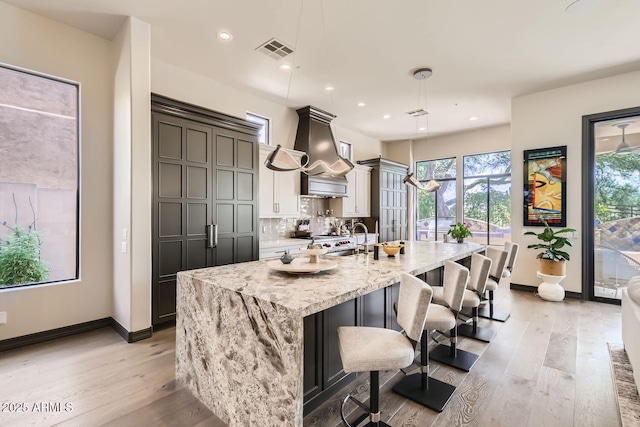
[0,66,79,288]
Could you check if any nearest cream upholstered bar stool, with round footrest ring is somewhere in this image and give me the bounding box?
[338,273,432,427]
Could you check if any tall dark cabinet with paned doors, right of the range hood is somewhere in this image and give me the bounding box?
[358,158,409,242]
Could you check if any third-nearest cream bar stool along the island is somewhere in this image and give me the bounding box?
[427,260,480,372]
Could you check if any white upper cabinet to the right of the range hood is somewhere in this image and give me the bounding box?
[330,165,371,218]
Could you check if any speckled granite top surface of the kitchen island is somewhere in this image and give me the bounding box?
[178,239,484,316]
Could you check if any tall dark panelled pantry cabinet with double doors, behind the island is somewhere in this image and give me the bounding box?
[151,95,258,326]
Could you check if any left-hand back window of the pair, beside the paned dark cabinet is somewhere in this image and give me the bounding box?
[416,157,457,240]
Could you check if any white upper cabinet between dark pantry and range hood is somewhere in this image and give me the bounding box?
[259,144,304,218]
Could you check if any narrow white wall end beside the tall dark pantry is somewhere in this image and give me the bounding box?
[113,18,152,332]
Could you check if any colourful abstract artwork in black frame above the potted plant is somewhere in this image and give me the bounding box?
[523,145,567,227]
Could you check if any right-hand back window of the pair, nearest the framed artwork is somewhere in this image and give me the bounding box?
[463,151,511,245]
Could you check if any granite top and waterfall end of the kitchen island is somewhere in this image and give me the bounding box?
[176,242,483,426]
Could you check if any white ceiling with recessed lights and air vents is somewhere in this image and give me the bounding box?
[4,0,640,140]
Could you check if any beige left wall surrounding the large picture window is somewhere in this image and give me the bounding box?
[0,2,113,340]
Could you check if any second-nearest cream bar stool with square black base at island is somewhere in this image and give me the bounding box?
[393,261,469,412]
